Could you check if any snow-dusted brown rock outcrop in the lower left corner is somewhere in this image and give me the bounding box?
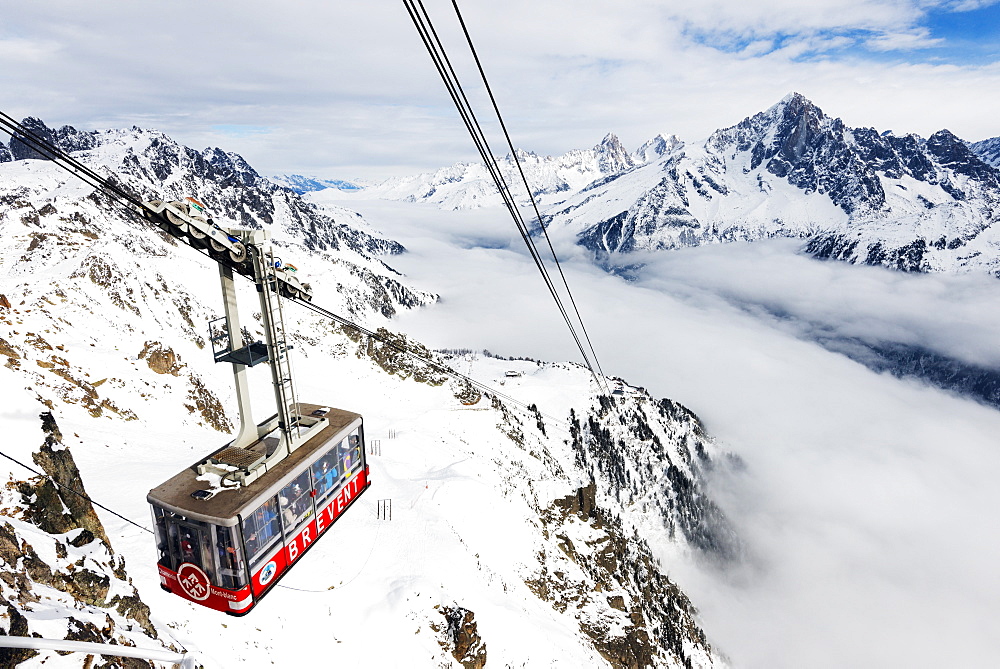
[0,405,178,667]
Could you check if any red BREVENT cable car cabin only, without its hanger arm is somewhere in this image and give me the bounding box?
[146,404,370,616]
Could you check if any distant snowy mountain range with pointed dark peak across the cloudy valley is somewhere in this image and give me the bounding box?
[350,93,1000,273]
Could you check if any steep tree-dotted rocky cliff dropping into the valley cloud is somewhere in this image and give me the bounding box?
[472,363,742,669]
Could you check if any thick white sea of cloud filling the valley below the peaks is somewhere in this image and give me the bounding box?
[332,202,1000,669]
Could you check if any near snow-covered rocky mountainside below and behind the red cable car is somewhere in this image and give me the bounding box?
[0,121,740,667]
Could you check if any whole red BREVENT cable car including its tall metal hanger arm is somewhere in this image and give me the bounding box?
[146,222,371,615]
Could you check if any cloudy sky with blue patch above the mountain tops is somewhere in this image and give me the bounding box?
[0,0,1000,179]
